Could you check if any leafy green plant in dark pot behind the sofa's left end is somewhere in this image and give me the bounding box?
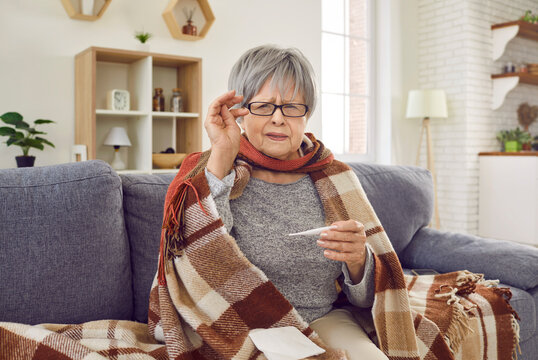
[0,112,54,167]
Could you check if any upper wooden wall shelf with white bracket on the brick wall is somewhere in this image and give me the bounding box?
[491,20,538,61]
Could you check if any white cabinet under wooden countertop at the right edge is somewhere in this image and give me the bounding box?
[479,152,538,246]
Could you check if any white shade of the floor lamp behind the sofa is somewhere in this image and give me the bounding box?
[405,89,448,118]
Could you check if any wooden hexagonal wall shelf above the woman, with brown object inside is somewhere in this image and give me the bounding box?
[163,0,215,41]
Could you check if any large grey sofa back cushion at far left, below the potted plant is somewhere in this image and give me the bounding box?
[0,161,133,324]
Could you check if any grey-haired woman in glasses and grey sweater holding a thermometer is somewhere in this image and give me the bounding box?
[205,46,385,359]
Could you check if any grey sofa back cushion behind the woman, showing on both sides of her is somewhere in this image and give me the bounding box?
[120,163,433,322]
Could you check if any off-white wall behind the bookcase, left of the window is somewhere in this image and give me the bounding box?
[0,0,321,168]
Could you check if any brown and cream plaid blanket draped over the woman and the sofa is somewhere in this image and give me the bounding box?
[0,144,518,360]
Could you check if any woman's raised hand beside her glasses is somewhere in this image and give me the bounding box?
[204,90,248,179]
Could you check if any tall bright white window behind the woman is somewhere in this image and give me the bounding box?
[321,0,374,158]
